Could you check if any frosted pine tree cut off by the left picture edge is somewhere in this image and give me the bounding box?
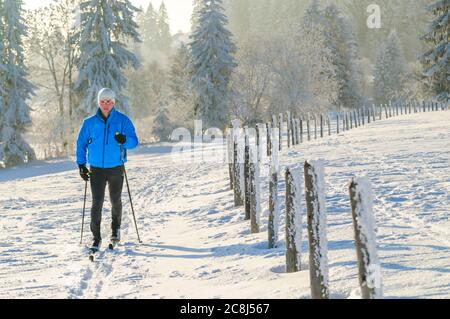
[0,0,35,167]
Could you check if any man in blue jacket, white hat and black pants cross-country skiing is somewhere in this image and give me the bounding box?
[77,88,138,252]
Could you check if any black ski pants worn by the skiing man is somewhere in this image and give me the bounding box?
[90,166,124,240]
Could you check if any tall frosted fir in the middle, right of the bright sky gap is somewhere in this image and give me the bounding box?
[190,0,236,127]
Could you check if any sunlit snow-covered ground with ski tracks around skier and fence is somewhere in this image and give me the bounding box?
[0,111,450,298]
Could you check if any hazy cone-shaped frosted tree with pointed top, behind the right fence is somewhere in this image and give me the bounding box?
[374,31,410,104]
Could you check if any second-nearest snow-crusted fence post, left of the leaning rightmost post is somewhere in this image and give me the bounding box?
[304,161,329,299]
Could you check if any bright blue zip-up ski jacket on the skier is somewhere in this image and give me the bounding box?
[77,108,139,168]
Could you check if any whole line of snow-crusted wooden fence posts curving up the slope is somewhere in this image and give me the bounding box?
[226,101,449,299]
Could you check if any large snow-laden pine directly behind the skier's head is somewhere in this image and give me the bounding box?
[75,0,140,114]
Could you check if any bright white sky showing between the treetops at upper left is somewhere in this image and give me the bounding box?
[24,0,192,34]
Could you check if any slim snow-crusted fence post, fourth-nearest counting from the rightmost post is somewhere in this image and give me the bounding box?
[267,145,280,249]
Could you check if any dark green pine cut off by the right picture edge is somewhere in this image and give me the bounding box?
[421,0,450,101]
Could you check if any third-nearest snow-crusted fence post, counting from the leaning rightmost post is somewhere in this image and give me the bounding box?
[286,168,302,273]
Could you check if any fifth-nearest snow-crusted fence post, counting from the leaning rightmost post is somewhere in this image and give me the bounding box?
[250,149,261,234]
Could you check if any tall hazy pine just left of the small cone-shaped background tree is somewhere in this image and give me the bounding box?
[324,5,362,108]
